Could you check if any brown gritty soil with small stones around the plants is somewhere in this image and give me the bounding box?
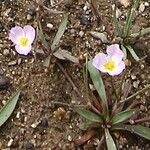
[0,0,150,150]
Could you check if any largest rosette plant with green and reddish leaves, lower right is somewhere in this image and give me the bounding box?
[74,61,150,150]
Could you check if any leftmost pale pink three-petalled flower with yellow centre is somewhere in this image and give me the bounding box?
[9,25,35,55]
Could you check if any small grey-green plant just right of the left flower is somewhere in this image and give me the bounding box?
[37,15,79,67]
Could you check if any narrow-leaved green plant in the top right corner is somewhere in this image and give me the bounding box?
[113,0,150,61]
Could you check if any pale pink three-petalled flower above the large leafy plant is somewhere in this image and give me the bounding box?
[92,44,125,76]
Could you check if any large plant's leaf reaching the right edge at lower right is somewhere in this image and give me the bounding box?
[111,124,150,140]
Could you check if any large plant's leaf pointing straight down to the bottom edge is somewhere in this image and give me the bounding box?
[105,129,117,150]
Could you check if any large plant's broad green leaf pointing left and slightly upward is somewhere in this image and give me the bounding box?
[74,106,103,123]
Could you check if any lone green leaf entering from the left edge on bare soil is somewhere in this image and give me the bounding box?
[0,91,20,126]
